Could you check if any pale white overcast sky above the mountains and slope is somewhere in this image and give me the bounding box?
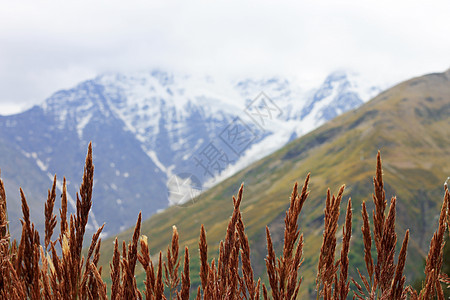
[0,0,450,115]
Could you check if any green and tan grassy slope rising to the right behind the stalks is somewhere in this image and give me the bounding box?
[94,72,450,295]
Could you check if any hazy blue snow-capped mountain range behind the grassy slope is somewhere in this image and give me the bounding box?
[0,71,381,234]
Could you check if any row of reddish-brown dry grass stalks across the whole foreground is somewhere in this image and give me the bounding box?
[0,145,450,300]
